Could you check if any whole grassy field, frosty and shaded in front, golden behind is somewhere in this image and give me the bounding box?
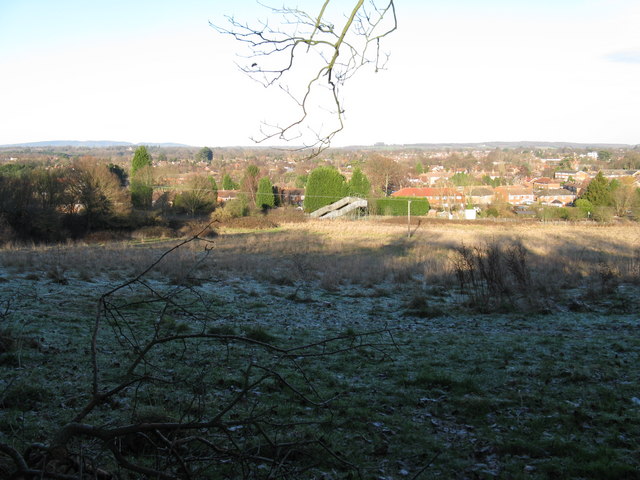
[0,221,640,479]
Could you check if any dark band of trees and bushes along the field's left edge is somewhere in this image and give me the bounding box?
[0,146,287,242]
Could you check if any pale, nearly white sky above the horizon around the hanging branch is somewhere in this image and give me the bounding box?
[0,0,640,147]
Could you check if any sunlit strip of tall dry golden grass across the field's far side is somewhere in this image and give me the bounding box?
[0,221,640,300]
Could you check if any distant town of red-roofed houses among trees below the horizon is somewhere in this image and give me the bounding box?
[0,142,640,239]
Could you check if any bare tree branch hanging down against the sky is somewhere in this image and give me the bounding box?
[210,0,397,155]
